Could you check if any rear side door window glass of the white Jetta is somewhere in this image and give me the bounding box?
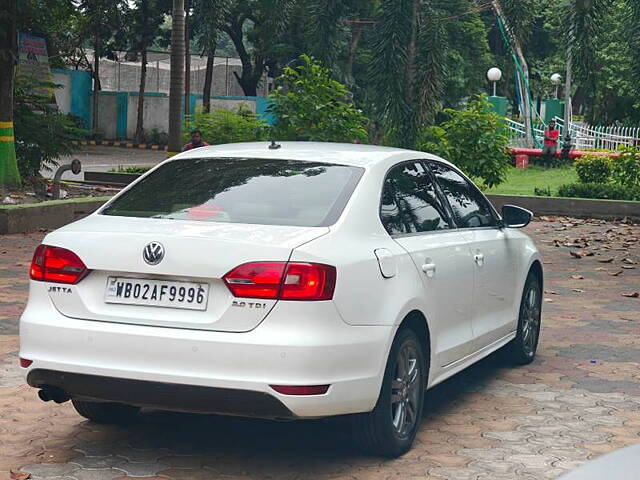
[380,163,449,235]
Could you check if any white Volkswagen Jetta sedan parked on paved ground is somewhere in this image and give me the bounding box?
[20,142,543,456]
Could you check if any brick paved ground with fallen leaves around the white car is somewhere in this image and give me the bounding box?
[0,218,640,480]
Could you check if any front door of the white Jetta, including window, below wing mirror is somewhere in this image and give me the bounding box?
[430,162,518,349]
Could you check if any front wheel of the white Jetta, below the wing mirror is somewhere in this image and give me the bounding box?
[503,273,542,365]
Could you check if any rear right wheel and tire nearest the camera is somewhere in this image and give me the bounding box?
[352,328,428,458]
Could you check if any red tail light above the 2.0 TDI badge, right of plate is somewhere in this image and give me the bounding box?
[223,262,336,300]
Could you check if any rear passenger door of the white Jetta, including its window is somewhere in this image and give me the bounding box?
[380,162,473,366]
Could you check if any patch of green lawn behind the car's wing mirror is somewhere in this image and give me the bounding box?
[485,166,578,195]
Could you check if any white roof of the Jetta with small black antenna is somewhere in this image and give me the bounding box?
[174,142,449,167]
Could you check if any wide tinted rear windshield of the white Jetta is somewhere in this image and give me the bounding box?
[101,158,364,227]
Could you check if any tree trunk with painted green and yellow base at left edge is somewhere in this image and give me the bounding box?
[0,0,21,189]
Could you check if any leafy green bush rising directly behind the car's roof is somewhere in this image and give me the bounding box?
[269,55,368,143]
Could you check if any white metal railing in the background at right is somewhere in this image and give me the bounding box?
[505,118,640,151]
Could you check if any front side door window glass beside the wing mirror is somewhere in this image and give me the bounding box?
[431,162,495,228]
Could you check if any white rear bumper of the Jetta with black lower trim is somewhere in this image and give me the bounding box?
[20,299,394,418]
